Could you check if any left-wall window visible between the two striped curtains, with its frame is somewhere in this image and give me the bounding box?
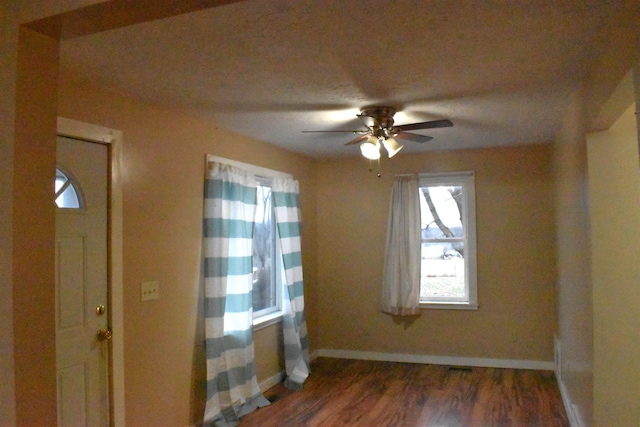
[253,178,282,323]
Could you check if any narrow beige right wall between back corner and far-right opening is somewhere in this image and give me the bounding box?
[553,84,593,425]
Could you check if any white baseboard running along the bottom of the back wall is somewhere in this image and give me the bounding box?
[313,349,554,371]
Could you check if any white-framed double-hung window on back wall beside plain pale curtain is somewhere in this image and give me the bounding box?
[419,172,478,309]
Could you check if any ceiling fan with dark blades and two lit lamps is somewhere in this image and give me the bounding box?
[303,106,453,160]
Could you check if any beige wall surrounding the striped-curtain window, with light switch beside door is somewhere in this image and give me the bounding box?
[59,72,316,426]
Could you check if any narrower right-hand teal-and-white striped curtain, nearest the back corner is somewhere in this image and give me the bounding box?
[272,178,310,390]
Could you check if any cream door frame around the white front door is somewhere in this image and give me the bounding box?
[57,117,125,426]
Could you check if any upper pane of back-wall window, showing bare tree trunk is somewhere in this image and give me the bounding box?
[420,186,464,239]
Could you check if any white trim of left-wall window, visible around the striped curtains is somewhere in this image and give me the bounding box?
[207,154,293,331]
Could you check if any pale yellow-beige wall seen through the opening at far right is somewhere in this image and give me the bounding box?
[587,105,640,427]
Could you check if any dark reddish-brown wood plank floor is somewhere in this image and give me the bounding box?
[240,358,569,427]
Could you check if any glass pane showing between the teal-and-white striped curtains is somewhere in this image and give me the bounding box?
[253,185,276,313]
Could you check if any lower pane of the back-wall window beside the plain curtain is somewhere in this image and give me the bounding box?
[420,243,467,298]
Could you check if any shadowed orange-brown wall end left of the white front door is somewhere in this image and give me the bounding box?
[12,28,58,424]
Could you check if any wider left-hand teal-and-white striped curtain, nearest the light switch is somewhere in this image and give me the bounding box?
[203,163,269,427]
